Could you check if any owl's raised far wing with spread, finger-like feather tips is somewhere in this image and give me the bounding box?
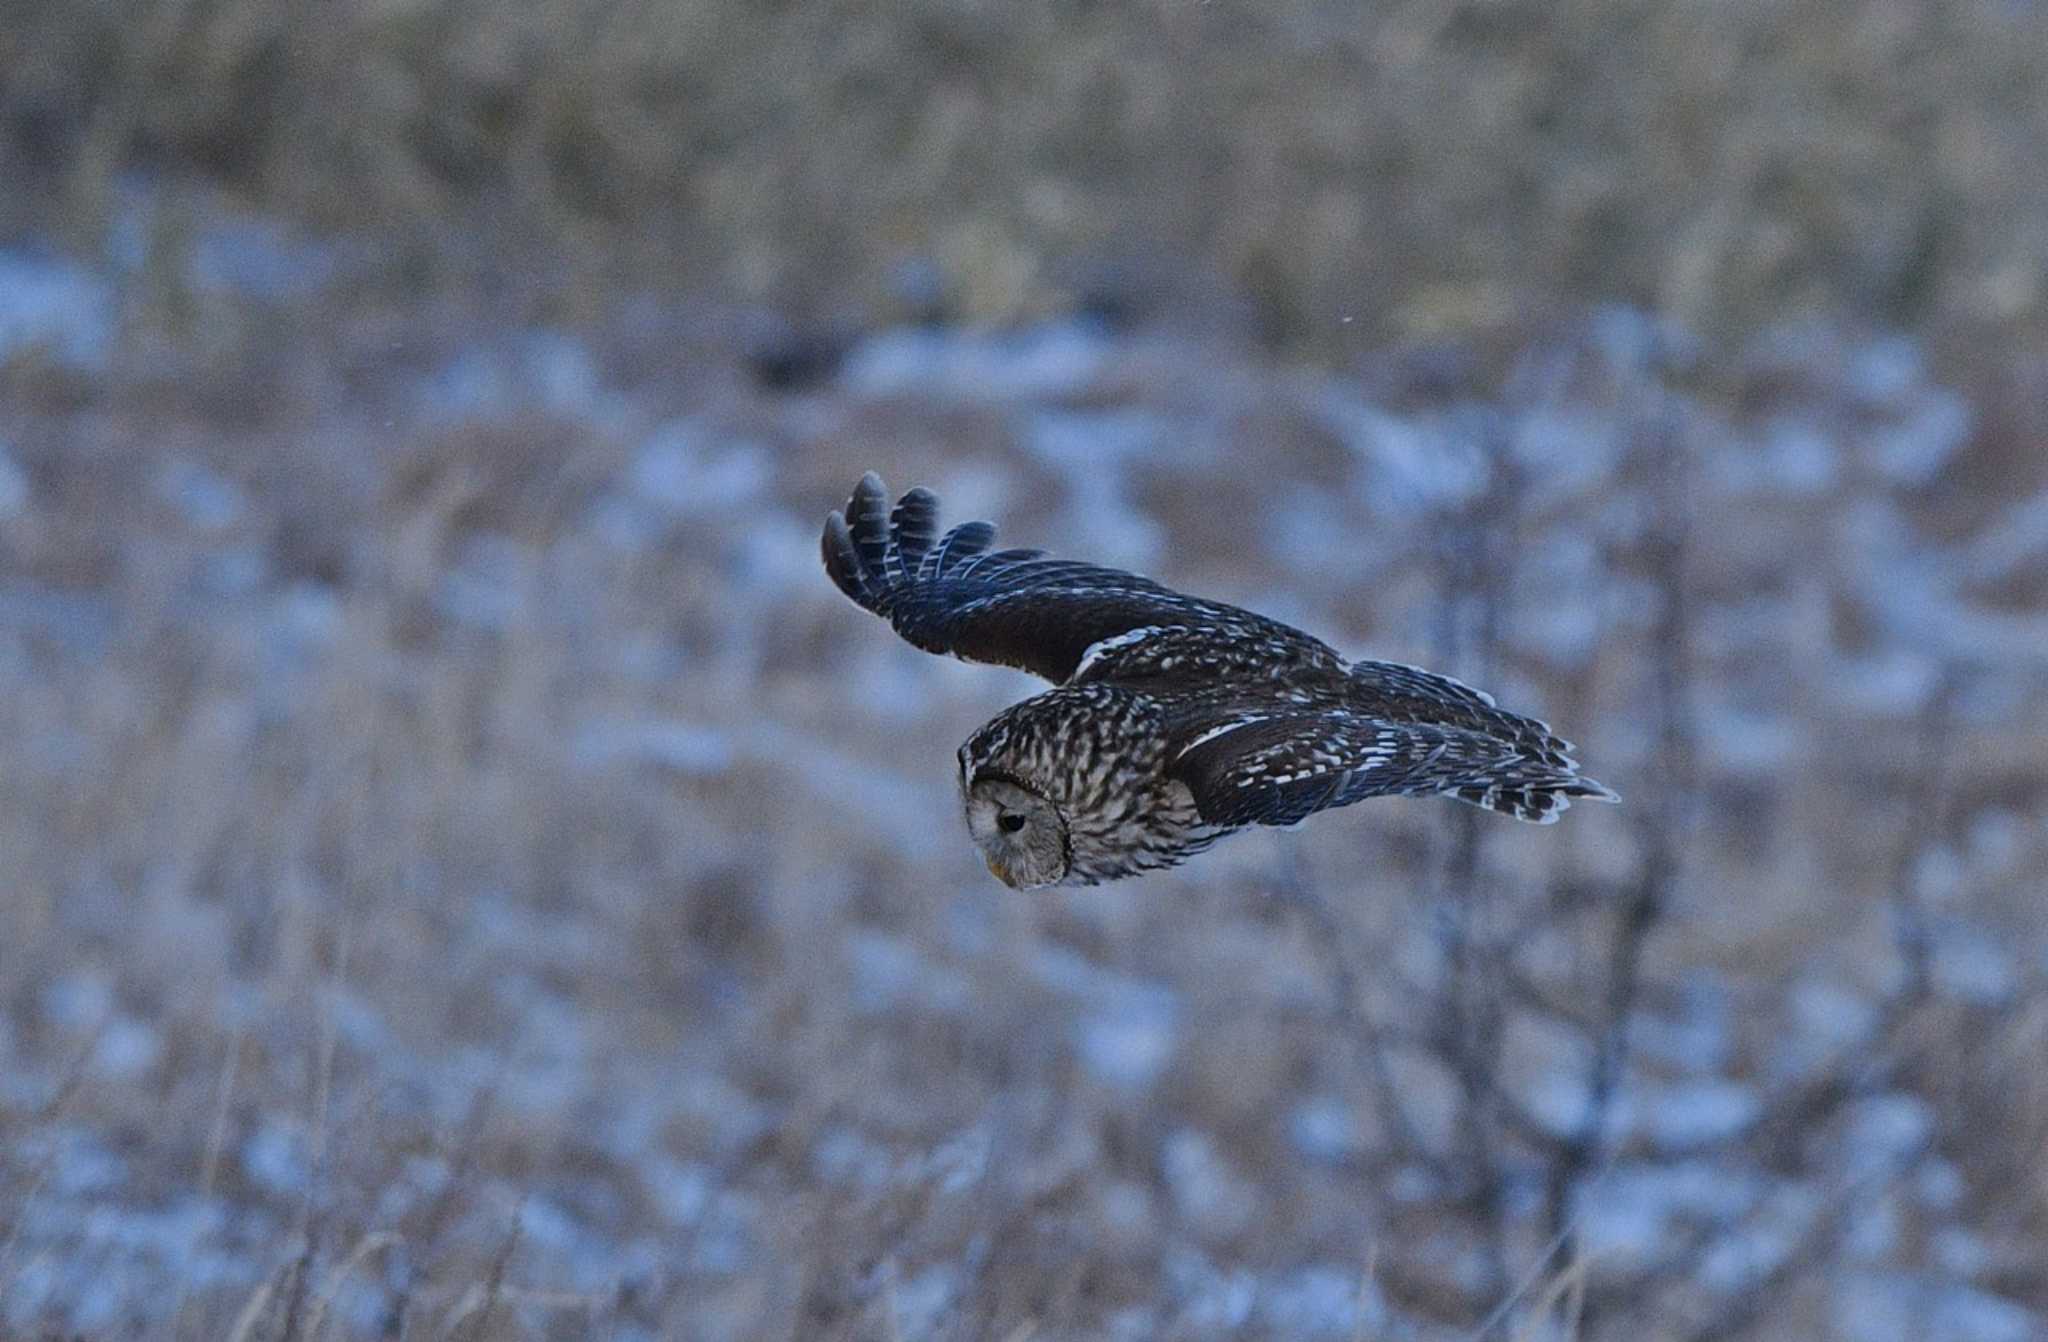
[823,471,1335,682]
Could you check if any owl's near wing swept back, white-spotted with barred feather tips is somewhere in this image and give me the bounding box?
[1167,705,1616,826]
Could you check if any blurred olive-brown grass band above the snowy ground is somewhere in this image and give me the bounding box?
[0,0,2048,357]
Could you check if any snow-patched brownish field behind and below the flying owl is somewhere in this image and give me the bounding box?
[0,227,2048,1342]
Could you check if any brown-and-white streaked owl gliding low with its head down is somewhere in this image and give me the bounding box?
[823,473,1618,889]
